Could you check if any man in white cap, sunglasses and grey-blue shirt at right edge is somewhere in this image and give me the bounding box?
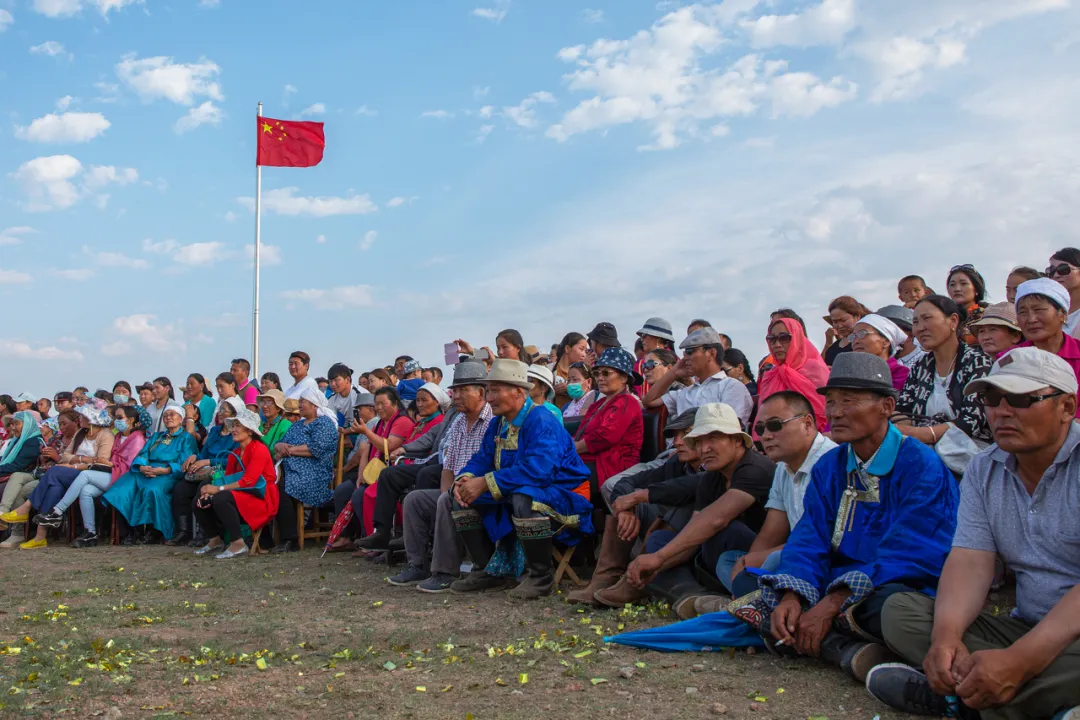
[866,345,1080,720]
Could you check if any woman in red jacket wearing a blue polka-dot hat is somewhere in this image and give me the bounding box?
[575,348,645,489]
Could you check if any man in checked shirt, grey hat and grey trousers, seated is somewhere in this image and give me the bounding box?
[388,361,491,593]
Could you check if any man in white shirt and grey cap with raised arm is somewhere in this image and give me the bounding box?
[642,327,754,427]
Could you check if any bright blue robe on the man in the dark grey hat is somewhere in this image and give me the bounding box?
[759,425,960,609]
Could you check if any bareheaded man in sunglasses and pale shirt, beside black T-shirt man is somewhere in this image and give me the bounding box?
[712,390,836,614]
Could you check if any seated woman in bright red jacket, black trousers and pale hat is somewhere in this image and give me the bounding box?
[194,408,278,560]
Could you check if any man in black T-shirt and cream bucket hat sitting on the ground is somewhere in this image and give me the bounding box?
[597,403,775,619]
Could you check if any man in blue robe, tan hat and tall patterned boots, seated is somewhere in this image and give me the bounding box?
[450,359,593,600]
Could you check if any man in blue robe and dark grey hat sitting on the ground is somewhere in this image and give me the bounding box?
[731,353,959,682]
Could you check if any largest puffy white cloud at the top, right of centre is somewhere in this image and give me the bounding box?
[545,2,854,150]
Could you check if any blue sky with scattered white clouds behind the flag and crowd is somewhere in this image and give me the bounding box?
[0,0,1080,394]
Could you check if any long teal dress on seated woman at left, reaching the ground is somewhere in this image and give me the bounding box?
[102,430,199,538]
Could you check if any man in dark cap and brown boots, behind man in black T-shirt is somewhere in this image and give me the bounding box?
[566,410,700,608]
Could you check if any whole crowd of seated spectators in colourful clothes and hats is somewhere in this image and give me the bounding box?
[0,254,1080,720]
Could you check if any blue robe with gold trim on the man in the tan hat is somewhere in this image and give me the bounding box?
[458,399,593,545]
